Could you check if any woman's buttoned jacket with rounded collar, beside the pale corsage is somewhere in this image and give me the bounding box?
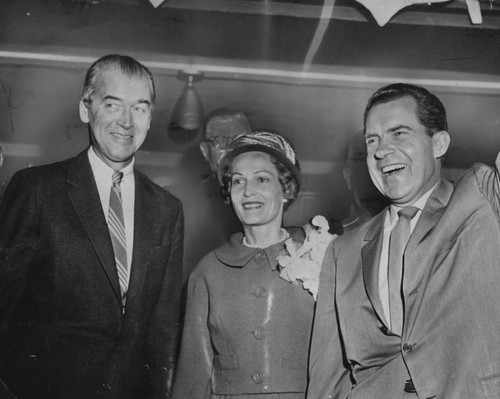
[174,233,314,399]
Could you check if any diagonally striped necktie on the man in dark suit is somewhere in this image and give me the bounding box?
[108,170,128,306]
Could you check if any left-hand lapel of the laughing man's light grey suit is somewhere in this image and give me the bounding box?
[361,210,388,327]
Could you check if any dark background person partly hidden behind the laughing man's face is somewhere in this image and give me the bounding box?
[342,131,388,232]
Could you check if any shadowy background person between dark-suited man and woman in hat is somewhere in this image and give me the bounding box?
[172,108,251,275]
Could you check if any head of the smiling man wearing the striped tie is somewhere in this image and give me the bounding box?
[80,54,156,170]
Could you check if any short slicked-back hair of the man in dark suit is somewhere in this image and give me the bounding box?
[82,54,156,104]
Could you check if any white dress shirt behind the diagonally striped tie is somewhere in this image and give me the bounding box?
[88,146,135,283]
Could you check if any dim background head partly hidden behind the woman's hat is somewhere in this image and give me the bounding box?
[200,108,252,175]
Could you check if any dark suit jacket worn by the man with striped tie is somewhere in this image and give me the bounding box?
[0,151,183,399]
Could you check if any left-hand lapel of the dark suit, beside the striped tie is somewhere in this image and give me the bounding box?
[68,151,121,306]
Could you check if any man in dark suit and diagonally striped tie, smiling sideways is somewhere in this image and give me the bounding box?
[0,55,183,399]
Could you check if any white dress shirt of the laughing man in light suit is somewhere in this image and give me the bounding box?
[378,183,437,325]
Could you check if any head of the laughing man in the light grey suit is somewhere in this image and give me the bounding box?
[364,83,450,207]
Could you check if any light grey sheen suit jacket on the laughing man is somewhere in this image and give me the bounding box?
[308,165,500,399]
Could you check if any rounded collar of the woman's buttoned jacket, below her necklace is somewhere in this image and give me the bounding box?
[215,227,305,270]
